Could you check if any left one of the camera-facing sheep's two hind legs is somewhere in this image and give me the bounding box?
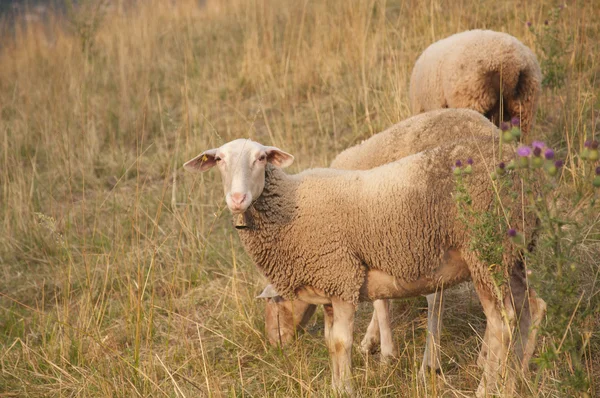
[475,283,515,397]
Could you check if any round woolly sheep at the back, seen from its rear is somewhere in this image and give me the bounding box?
[409,30,542,137]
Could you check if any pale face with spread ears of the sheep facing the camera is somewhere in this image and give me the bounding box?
[183,138,294,214]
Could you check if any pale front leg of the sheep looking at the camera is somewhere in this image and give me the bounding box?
[325,299,355,395]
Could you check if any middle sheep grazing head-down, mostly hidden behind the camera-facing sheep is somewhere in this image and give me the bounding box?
[260,109,497,356]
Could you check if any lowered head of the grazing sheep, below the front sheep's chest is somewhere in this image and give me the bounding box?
[257,285,317,346]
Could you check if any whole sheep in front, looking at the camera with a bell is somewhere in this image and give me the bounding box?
[184,130,535,396]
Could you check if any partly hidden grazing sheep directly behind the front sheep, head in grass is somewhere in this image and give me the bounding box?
[258,109,545,374]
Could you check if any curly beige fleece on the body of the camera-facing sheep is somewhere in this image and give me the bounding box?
[238,136,522,304]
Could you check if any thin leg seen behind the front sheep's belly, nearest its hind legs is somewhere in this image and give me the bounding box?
[419,292,444,377]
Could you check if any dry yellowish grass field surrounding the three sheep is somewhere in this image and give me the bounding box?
[0,0,600,397]
